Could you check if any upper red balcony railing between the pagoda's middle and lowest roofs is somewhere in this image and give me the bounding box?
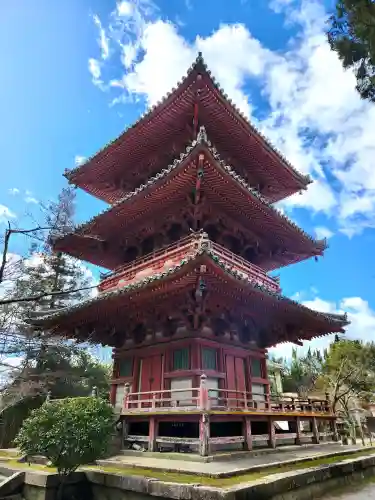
[98,233,280,293]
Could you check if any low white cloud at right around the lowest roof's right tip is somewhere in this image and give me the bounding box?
[270,297,375,358]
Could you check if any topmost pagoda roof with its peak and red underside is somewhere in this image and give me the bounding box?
[64,54,312,203]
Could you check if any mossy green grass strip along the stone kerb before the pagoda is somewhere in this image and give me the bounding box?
[0,448,375,488]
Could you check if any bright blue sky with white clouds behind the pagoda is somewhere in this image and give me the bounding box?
[0,0,375,360]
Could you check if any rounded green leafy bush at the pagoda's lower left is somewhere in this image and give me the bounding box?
[15,397,114,476]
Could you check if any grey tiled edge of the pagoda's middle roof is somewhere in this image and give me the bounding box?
[55,133,327,253]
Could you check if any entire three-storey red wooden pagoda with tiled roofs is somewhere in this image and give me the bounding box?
[33,55,348,455]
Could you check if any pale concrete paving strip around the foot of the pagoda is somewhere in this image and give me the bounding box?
[98,443,375,475]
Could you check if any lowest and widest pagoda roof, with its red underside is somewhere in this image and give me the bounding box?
[29,245,349,347]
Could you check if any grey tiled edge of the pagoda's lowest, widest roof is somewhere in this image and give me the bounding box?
[29,246,350,327]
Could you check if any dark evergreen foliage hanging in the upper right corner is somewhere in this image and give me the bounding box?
[328,0,375,102]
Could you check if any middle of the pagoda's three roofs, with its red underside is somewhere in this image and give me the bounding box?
[54,133,327,270]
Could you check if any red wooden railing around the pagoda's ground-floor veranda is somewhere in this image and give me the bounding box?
[122,375,332,415]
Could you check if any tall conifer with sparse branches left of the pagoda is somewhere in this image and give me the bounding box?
[2,188,92,402]
